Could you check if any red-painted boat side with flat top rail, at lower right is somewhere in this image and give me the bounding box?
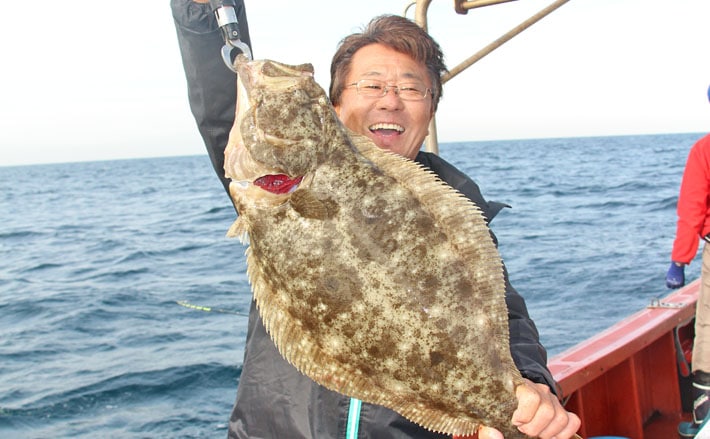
[548,281,700,439]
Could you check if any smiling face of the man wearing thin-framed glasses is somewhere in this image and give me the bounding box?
[335,44,434,159]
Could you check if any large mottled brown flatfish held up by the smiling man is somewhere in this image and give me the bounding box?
[225,59,525,438]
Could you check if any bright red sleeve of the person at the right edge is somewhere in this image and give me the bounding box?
[671,136,710,264]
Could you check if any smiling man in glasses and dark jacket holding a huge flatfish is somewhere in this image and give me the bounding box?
[172,0,579,439]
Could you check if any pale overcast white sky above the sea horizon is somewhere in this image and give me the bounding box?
[0,0,710,165]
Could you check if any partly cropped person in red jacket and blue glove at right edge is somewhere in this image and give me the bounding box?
[666,84,710,438]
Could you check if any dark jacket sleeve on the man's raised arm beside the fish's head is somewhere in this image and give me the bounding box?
[170,0,251,194]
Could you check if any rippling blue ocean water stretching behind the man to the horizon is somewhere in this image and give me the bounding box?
[0,133,701,439]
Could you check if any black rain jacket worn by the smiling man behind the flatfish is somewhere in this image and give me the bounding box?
[171,0,556,439]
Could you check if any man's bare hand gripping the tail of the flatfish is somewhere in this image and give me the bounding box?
[478,379,581,439]
